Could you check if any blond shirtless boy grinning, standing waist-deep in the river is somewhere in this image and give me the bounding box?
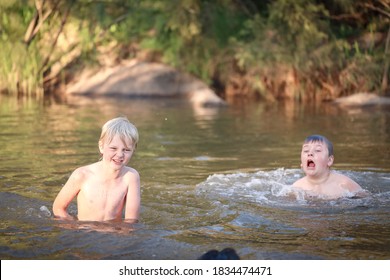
[53,117,141,221]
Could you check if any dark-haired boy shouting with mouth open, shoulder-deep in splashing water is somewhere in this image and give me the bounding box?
[293,135,364,199]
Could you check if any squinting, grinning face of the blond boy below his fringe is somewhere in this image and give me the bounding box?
[99,135,134,170]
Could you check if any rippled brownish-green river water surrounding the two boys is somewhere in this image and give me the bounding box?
[0,97,390,260]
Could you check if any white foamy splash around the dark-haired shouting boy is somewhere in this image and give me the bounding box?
[197,168,390,208]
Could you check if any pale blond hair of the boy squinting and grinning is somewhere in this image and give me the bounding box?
[99,117,139,148]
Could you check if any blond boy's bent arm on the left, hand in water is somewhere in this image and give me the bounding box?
[53,170,80,219]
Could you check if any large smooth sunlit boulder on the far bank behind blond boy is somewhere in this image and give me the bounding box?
[65,60,226,106]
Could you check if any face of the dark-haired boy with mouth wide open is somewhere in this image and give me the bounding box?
[301,142,333,176]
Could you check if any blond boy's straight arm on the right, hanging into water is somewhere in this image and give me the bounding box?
[125,170,141,222]
